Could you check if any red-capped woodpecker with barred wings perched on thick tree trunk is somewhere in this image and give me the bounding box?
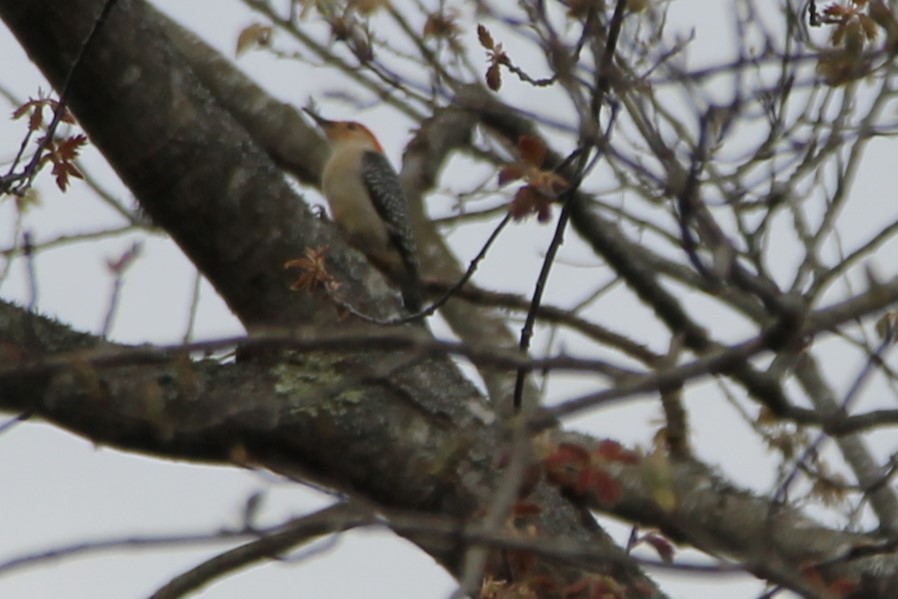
[305,109,421,312]
